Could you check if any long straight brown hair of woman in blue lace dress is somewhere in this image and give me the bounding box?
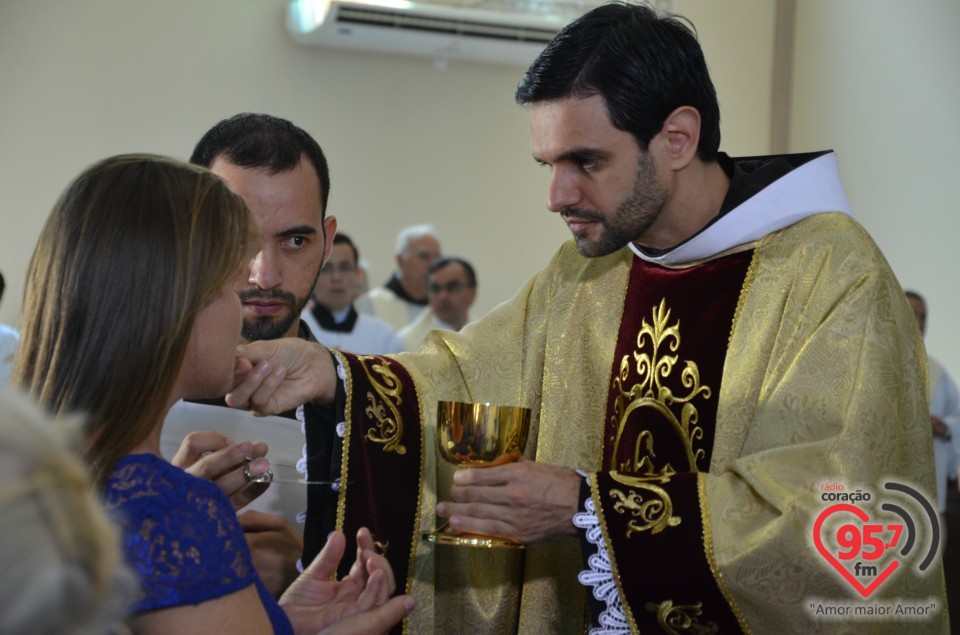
[13,155,256,487]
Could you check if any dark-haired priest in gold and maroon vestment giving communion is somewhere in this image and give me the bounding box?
[230,4,948,635]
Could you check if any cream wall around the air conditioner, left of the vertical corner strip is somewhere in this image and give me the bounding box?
[0,0,773,322]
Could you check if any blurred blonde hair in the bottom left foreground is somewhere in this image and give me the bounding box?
[0,388,136,635]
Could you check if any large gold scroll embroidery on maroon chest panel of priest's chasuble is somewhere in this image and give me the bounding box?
[610,299,713,475]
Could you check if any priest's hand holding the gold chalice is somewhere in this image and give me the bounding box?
[437,460,581,544]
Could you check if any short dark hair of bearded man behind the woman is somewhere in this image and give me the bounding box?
[190,113,330,217]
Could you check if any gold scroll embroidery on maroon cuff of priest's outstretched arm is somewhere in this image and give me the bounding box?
[357,355,407,454]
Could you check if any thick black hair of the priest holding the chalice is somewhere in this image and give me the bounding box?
[516,3,720,161]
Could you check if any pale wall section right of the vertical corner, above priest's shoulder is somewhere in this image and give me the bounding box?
[790,0,960,376]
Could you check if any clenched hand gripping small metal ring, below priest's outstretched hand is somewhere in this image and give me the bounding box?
[170,432,270,509]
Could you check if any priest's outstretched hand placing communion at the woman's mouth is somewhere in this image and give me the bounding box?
[226,338,337,415]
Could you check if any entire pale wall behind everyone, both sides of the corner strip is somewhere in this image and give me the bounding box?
[22,0,960,374]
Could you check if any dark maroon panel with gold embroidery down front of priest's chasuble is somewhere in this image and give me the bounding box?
[592,249,754,632]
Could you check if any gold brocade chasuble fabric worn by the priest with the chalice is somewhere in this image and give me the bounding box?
[338,214,946,633]
